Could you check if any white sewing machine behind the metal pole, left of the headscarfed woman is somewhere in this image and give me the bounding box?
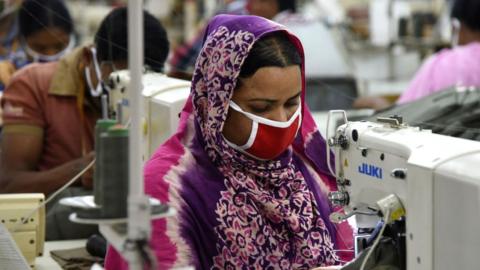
[109,70,191,161]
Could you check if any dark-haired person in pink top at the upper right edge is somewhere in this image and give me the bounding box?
[397,0,480,103]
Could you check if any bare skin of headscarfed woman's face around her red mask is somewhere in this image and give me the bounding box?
[222,65,302,145]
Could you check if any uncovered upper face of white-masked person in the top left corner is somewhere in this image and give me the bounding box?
[25,27,70,55]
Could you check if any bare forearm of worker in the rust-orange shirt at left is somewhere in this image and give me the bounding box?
[0,133,94,194]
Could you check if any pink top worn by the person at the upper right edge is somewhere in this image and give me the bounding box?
[397,42,480,104]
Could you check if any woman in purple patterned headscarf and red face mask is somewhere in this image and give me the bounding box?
[106,15,351,269]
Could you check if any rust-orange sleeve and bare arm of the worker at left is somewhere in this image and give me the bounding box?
[0,65,93,194]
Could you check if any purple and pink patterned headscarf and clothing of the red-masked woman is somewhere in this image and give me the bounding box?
[106,15,351,269]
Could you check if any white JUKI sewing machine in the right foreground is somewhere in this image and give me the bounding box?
[329,114,480,270]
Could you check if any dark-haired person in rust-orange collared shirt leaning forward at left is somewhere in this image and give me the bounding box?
[0,8,169,240]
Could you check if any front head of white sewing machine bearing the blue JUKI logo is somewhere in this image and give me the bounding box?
[329,118,410,228]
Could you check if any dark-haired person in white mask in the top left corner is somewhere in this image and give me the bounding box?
[0,0,75,90]
